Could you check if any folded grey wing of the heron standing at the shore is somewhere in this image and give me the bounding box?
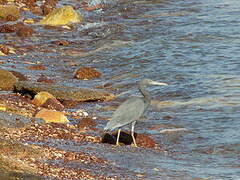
[105,97,144,130]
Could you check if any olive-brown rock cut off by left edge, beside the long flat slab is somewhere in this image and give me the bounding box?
[0,69,18,90]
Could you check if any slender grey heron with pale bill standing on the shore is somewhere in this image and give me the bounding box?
[104,79,168,147]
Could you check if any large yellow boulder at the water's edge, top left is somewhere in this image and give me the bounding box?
[39,6,82,26]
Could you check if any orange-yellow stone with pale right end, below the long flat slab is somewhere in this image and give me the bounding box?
[35,108,69,123]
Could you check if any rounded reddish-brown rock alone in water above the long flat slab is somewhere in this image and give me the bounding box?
[74,67,101,80]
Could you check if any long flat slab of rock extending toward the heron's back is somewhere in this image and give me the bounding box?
[14,81,114,101]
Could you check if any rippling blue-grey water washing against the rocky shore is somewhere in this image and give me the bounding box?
[0,0,240,179]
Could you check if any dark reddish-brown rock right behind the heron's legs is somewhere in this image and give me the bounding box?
[102,131,156,148]
